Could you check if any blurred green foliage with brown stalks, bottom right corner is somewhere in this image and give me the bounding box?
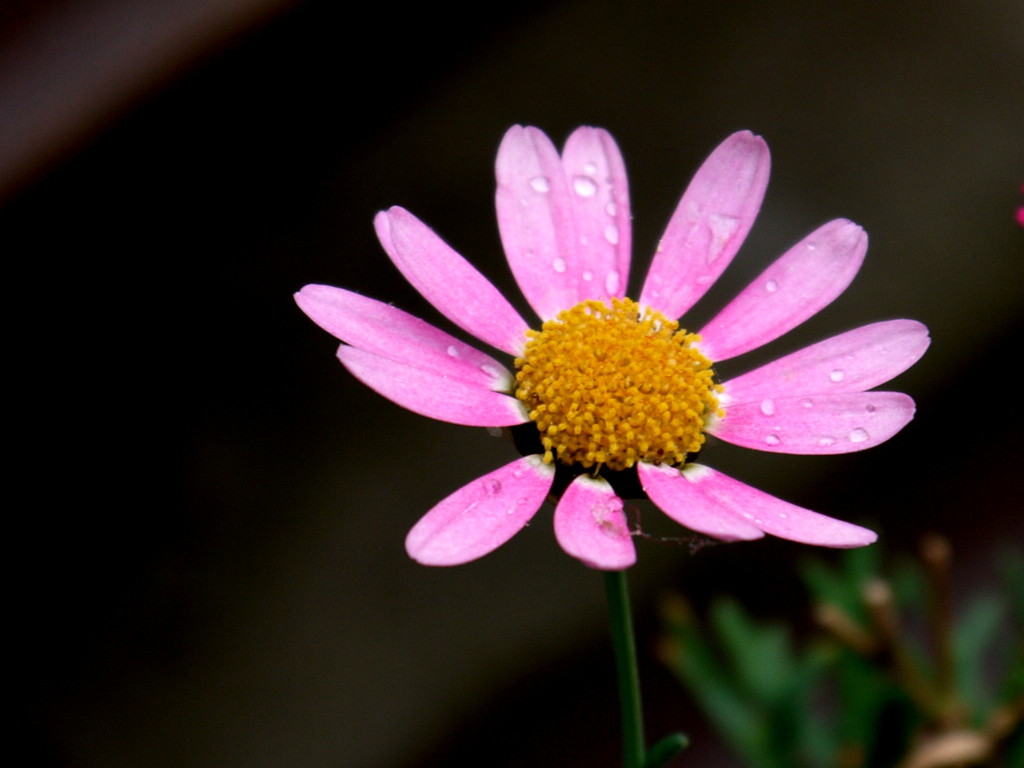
[663,539,1024,768]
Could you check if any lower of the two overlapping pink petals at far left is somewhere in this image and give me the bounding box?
[338,344,529,427]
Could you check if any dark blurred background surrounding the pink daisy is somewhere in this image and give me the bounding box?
[6,0,1024,768]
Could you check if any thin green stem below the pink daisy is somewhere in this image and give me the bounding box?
[604,570,645,768]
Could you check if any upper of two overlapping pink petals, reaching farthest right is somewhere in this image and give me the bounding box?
[720,319,931,404]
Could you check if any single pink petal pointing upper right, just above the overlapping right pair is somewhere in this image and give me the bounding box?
[700,219,867,362]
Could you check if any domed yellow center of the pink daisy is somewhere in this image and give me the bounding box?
[515,299,721,470]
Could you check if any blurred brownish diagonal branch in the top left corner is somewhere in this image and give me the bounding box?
[0,0,296,202]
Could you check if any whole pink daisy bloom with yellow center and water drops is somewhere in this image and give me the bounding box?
[296,126,929,570]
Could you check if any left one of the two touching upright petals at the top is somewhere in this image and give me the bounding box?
[495,125,580,319]
